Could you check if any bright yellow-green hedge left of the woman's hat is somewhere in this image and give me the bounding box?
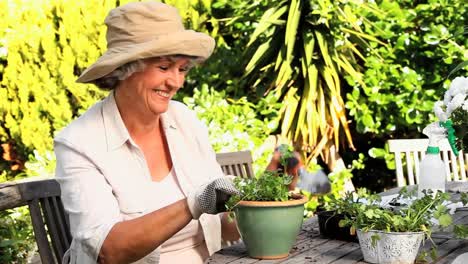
[0,0,115,177]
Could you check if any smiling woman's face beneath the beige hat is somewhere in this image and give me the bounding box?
[118,57,190,115]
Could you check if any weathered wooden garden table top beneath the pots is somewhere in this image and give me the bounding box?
[207,182,468,264]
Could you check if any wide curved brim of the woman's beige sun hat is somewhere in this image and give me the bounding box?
[76,30,215,83]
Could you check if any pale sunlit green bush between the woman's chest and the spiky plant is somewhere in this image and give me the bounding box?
[183,85,280,172]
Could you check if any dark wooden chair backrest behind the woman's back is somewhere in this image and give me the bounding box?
[0,179,72,263]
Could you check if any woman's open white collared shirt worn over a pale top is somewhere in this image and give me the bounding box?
[54,92,224,264]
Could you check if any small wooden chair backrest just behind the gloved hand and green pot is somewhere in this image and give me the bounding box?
[216,150,254,178]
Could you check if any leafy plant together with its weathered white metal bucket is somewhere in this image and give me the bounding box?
[340,188,460,264]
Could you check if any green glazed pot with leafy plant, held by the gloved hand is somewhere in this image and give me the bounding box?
[226,146,308,259]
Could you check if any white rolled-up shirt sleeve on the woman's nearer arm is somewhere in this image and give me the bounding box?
[54,140,122,264]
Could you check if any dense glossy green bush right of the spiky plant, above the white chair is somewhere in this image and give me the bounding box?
[346,0,468,138]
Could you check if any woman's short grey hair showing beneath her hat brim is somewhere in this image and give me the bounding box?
[92,55,199,91]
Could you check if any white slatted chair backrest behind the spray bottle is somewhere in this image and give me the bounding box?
[388,138,468,187]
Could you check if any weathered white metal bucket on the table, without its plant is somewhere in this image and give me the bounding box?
[357,230,424,264]
